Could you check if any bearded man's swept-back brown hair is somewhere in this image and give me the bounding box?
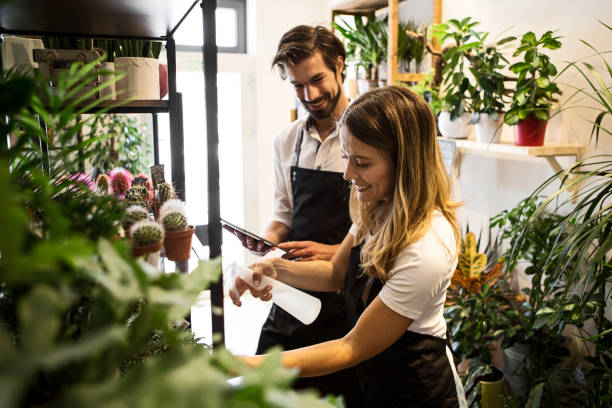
[272,25,346,80]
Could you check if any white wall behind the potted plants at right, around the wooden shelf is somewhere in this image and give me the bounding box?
[442,0,612,230]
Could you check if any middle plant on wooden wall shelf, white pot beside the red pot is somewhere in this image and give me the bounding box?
[469,33,515,143]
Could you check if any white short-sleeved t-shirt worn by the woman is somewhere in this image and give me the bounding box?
[349,212,457,338]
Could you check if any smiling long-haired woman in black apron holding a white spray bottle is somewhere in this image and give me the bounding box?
[231,86,465,407]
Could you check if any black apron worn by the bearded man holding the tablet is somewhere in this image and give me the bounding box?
[257,128,360,408]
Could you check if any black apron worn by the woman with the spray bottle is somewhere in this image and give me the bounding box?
[344,246,459,408]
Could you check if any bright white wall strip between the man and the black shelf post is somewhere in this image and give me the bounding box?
[245,0,330,231]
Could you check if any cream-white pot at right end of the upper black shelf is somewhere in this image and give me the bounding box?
[115,57,159,100]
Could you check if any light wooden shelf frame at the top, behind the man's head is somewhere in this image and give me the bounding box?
[331,0,442,84]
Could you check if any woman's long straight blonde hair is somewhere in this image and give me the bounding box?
[339,86,461,282]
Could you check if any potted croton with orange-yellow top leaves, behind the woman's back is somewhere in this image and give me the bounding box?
[444,231,511,408]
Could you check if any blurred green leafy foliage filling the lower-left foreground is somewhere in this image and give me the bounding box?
[0,59,332,407]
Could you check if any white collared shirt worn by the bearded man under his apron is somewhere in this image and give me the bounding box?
[271,116,344,227]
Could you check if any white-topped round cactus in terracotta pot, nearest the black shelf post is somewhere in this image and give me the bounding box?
[160,200,195,262]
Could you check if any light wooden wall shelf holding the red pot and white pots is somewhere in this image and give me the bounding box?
[438,137,586,200]
